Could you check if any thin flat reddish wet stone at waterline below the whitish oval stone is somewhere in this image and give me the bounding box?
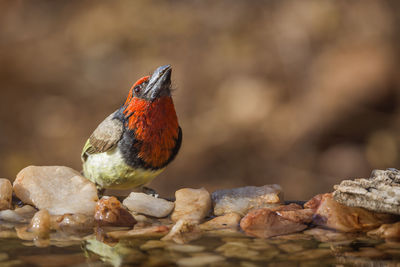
[107,225,171,239]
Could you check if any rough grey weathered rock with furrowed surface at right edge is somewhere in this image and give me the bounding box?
[333,169,400,215]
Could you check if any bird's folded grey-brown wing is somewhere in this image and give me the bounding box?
[81,111,124,161]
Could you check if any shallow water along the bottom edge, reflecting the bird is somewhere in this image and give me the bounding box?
[0,228,400,267]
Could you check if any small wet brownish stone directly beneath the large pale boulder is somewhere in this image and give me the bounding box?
[51,214,94,233]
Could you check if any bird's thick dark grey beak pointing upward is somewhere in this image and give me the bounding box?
[143,65,172,101]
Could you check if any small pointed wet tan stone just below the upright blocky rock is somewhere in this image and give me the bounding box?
[161,220,202,244]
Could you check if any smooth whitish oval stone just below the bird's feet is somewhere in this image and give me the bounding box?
[122,192,175,218]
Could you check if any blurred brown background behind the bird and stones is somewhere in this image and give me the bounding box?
[0,0,400,200]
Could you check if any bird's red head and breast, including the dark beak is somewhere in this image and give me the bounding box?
[124,65,179,167]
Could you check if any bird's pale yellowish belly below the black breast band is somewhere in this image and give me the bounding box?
[83,148,164,189]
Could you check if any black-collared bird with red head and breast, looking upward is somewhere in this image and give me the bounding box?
[81,65,182,190]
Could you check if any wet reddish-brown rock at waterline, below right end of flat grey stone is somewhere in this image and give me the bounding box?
[240,204,308,238]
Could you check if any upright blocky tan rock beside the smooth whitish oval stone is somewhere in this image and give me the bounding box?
[171,188,211,222]
